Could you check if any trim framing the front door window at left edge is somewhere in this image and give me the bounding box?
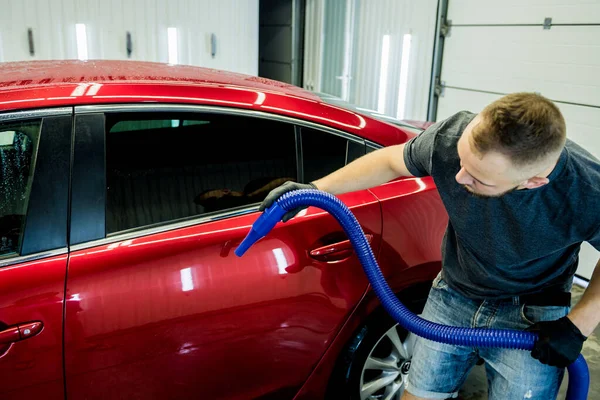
[0,107,73,268]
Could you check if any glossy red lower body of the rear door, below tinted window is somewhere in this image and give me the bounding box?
[65,191,381,399]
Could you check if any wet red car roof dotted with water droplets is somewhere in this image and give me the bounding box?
[0,60,412,145]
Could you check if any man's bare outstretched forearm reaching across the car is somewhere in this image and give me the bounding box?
[313,144,412,195]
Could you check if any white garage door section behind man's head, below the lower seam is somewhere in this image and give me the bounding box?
[437,88,600,279]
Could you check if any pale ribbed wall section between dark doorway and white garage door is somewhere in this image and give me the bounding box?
[304,0,438,120]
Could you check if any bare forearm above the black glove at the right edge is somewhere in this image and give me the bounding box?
[569,260,600,336]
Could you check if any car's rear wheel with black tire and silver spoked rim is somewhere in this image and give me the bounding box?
[326,283,431,400]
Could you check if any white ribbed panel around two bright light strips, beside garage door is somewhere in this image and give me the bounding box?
[352,0,437,120]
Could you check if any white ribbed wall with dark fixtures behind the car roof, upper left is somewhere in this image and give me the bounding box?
[0,0,259,75]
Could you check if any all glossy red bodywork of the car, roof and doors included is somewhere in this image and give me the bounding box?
[0,61,447,399]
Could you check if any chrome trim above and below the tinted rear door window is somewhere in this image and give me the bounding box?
[70,103,366,251]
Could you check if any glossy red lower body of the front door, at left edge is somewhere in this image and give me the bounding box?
[0,255,67,400]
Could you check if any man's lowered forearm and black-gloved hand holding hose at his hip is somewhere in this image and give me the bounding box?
[528,260,600,368]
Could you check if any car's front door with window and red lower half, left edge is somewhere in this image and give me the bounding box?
[0,108,72,399]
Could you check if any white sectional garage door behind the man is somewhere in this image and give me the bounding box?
[436,0,600,279]
